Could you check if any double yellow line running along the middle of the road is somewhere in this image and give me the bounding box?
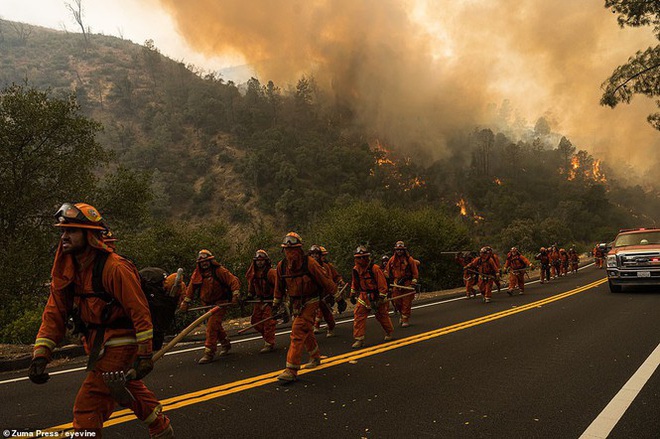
[44,279,607,431]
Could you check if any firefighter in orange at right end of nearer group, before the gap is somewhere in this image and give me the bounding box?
[384,241,419,328]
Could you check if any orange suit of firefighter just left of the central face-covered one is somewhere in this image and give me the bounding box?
[245,261,277,345]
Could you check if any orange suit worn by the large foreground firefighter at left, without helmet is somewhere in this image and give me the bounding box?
[33,237,170,437]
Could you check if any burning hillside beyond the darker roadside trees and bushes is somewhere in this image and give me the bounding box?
[0,17,660,239]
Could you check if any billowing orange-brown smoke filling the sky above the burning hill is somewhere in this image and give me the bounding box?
[160,0,660,177]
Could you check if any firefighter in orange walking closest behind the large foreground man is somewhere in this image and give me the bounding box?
[180,250,241,364]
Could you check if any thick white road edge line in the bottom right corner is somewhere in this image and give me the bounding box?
[580,344,660,439]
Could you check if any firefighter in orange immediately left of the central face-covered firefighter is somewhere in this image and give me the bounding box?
[245,250,277,354]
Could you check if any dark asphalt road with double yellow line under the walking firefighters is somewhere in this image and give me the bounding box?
[0,266,660,439]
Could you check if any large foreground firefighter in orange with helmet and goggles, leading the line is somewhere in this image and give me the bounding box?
[28,203,174,439]
